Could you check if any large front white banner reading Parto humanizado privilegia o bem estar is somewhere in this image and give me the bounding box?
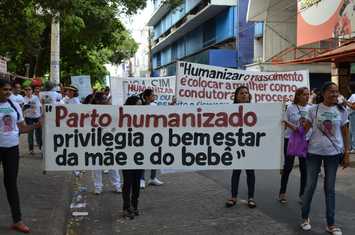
[44,103,283,171]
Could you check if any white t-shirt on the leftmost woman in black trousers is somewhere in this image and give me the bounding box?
[0,101,23,148]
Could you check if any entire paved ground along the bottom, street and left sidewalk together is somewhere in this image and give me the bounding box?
[0,135,355,235]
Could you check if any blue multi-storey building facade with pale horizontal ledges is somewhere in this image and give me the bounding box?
[148,0,254,76]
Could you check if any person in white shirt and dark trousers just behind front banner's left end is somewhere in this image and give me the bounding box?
[23,86,42,154]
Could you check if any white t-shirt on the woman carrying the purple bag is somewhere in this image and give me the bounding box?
[285,104,311,139]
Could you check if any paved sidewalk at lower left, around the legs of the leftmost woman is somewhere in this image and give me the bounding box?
[0,135,72,235]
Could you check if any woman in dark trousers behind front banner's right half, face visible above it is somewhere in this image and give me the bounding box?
[226,86,256,208]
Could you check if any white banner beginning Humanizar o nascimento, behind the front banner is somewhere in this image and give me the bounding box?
[176,61,309,105]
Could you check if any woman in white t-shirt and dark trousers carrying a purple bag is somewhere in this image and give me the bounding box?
[279,87,311,204]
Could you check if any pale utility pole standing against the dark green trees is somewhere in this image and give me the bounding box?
[50,13,60,85]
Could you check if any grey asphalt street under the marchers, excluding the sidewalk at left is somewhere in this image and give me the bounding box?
[67,163,355,235]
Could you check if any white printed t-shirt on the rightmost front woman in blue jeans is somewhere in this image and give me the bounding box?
[307,103,349,156]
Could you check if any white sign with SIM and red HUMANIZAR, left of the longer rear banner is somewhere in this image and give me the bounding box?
[123,76,176,105]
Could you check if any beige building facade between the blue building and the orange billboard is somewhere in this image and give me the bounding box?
[246,0,332,88]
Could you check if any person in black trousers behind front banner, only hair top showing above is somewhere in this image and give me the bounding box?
[122,96,144,219]
